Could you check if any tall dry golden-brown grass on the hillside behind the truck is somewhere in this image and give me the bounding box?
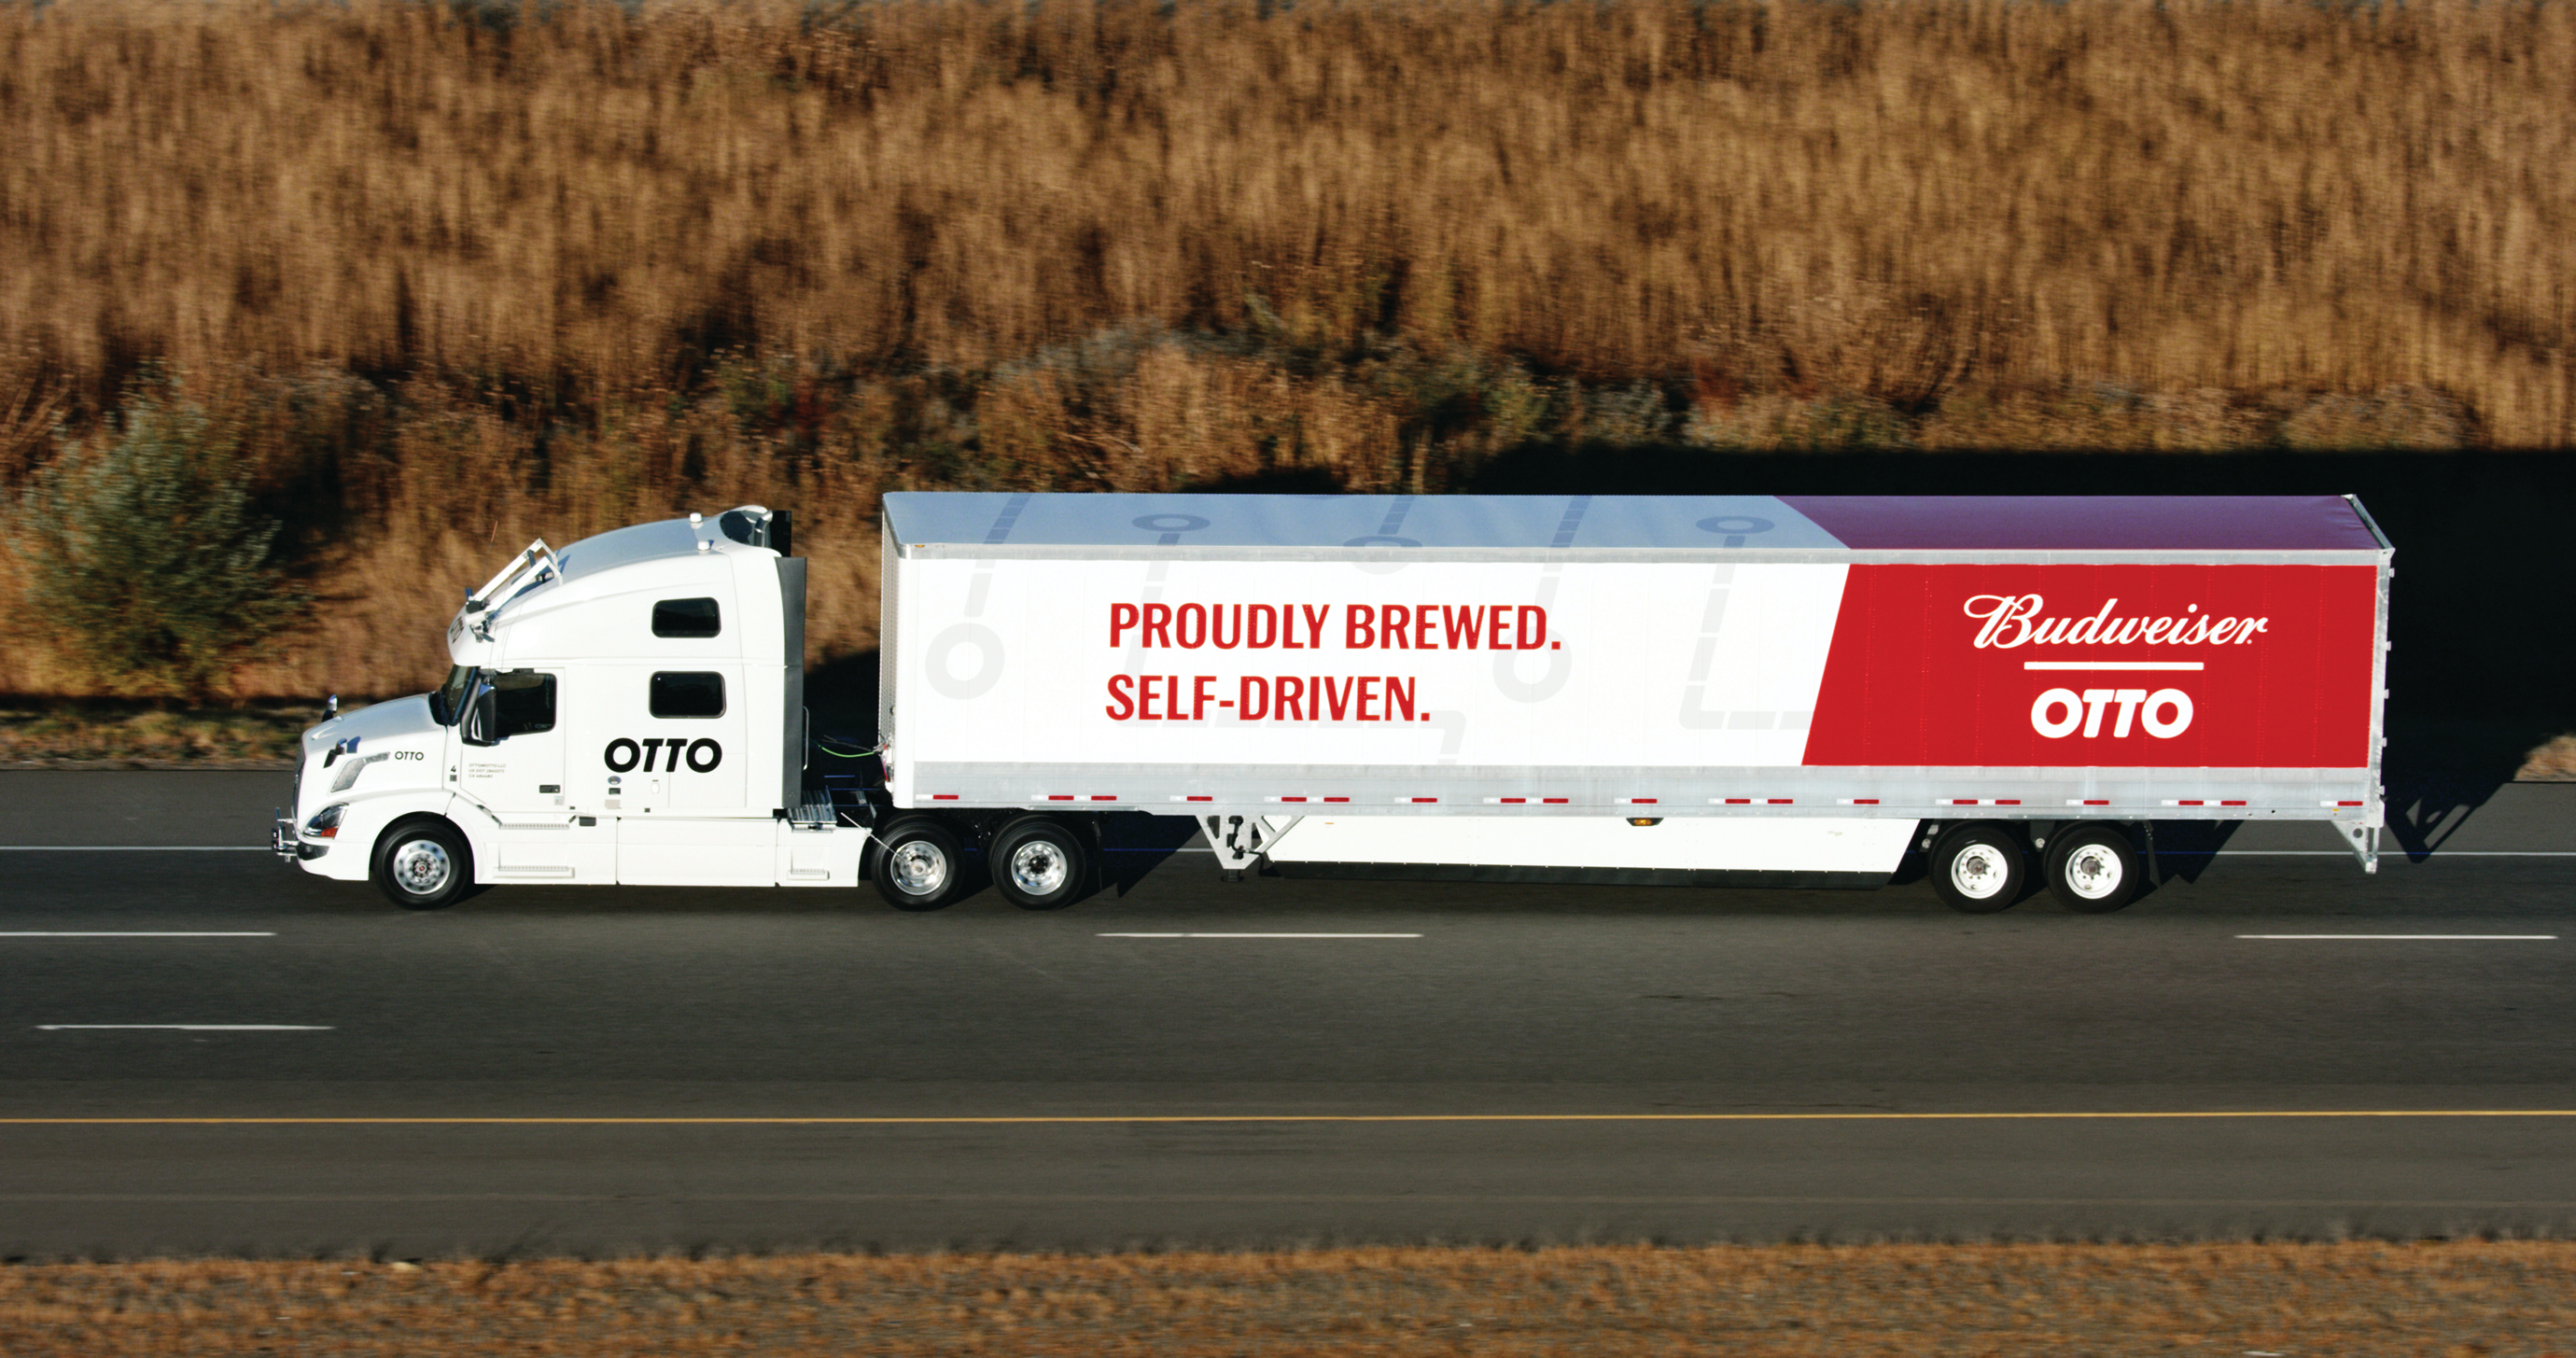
[0,0,2576,695]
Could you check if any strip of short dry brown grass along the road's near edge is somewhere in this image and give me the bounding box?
[0,1242,2576,1358]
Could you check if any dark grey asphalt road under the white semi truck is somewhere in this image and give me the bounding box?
[0,773,2576,1257]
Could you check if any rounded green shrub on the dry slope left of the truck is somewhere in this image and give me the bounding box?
[13,386,304,695]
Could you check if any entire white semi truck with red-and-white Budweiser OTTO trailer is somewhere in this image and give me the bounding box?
[273,492,2393,912]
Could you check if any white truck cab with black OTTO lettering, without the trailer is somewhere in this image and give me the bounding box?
[273,505,865,910]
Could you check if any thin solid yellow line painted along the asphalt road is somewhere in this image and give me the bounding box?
[0,1108,2576,1127]
